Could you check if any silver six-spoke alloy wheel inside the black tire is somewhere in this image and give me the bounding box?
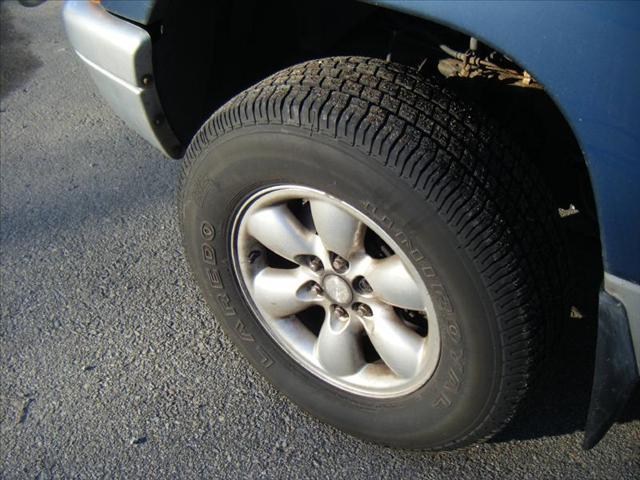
[231,185,440,398]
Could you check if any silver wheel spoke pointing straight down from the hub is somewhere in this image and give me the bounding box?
[315,313,365,376]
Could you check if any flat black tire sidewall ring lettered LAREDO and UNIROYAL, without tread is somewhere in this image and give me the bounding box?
[180,125,501,448]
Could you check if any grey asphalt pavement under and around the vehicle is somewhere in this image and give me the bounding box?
[0,1,640,480]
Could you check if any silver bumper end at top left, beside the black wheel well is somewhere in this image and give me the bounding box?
[62,0,181,158]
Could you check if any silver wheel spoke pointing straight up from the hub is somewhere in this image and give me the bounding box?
[310,200,362,258]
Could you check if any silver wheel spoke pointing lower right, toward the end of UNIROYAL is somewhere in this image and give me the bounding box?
[362,305,424,378]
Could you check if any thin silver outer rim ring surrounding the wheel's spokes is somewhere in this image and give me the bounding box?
[230,184,441,398]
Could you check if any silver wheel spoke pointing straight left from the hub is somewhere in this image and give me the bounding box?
[253,267,309,318]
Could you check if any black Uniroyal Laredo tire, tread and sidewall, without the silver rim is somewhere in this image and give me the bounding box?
[179,57,566,450]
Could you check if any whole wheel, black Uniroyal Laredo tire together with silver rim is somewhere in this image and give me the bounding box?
[179,58,564,450]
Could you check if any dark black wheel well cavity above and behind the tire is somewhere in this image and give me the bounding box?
[150,0,603,316]
